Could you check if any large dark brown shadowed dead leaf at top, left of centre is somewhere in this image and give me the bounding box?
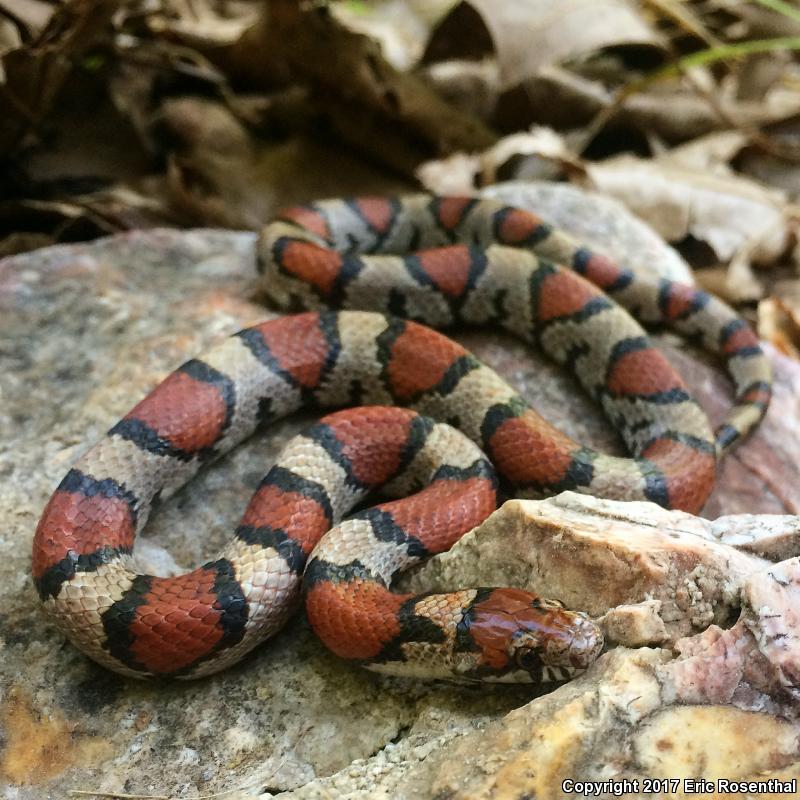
[225,0,497,175]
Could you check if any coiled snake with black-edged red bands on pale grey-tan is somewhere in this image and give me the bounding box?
[32,195,772,683]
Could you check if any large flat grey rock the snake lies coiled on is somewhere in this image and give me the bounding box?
[0,189,800,800]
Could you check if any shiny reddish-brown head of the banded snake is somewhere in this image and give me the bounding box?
[470,589,603,683]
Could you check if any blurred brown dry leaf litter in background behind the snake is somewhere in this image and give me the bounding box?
[0,0,800,355]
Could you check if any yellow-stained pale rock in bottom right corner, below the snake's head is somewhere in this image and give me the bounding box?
[431,648,800,800]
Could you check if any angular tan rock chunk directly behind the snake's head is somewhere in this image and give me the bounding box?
[403,492,772,643]
